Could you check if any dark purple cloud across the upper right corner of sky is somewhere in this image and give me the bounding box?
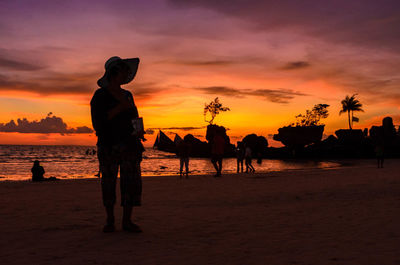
[169,0,400,53]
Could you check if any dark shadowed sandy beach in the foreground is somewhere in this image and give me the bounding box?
[0,160,400,264]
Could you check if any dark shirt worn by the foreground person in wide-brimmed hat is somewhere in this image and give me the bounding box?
[90,88,139,146]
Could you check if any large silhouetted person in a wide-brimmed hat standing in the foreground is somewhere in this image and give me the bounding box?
[90,56,144,233]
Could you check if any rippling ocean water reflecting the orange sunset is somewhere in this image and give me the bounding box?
[0,145,340,181]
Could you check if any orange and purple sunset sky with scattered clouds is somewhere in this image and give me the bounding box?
[0,0,400,146]
